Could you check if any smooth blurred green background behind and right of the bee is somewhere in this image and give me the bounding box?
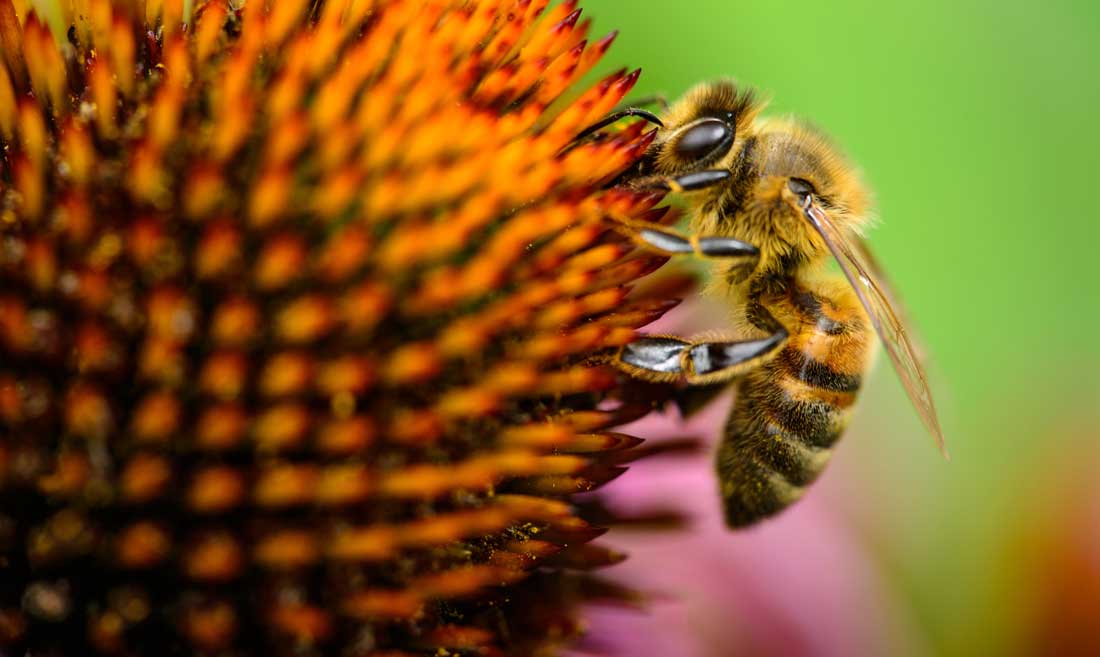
[583,0,1100,655]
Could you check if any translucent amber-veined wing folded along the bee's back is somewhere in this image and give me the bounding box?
[803,201,948,458]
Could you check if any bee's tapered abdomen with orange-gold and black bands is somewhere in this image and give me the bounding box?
[717,290,868,527]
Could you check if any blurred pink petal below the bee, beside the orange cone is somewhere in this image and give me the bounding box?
[584,395,926,657]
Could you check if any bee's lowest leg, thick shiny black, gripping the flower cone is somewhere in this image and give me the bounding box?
[616,327,788,385]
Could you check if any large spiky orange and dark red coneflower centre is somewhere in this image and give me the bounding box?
[0,0,670,655]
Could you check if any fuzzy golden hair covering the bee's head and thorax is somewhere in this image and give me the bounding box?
[639,80,870,282]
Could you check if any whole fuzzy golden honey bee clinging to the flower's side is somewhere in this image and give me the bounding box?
[594,81,947,527]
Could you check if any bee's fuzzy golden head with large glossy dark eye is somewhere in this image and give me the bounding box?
[642,80,761,176]
